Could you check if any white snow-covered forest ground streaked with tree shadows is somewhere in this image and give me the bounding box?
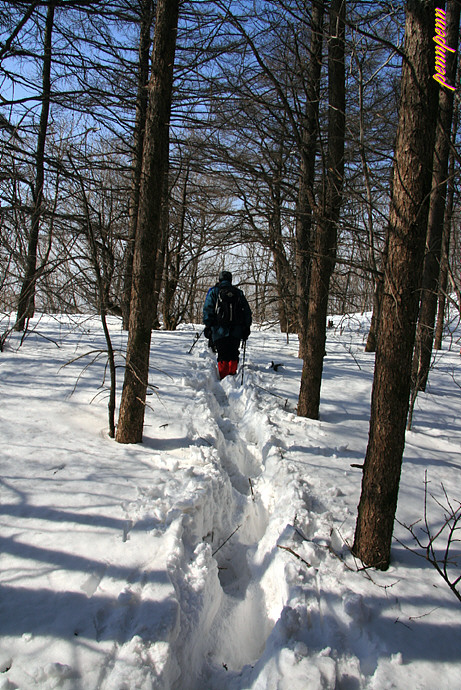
[0,316,461,690]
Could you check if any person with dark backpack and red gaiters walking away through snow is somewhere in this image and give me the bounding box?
[203,271,252,379]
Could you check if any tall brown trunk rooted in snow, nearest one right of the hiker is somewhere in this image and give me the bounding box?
[298,0,346,419]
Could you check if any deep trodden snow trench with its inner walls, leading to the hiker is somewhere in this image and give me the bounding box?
[170,354,316,690]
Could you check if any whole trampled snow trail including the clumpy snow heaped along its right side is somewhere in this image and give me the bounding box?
[170,354,373,690]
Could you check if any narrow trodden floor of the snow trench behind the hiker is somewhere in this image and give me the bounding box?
[201,370,272,680]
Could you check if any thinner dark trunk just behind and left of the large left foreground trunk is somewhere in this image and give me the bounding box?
[122,0,154,330]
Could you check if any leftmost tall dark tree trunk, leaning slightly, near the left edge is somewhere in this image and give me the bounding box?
[15,1,55,331]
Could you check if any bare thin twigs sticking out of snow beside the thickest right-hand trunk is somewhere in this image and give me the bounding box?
[396,472,461,601]
